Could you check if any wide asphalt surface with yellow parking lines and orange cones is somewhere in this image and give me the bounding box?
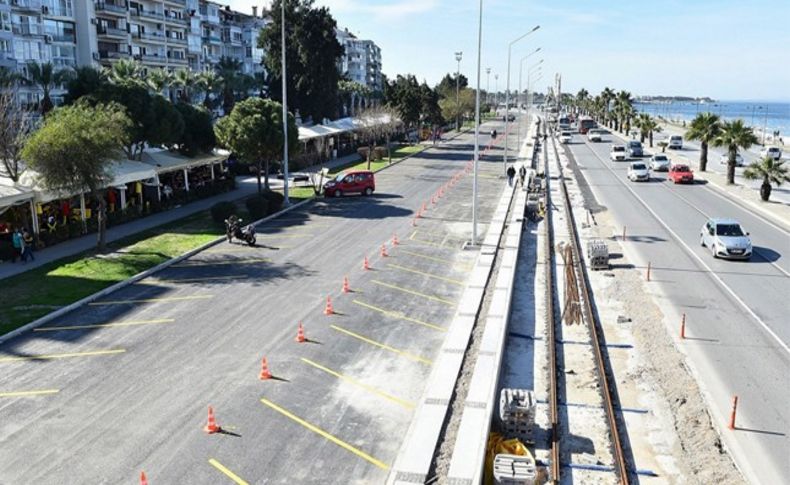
[0,123,505,485]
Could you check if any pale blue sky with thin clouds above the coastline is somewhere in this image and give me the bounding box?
[227,0,790,101]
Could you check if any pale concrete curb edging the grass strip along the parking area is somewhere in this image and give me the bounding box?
[0,198,315,344]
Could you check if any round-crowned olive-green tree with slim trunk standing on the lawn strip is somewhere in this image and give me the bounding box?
[22,103,131,251]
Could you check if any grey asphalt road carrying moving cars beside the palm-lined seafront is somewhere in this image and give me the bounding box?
[566,130,790,483]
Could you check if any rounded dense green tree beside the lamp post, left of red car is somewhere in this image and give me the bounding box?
[214,98,299,194]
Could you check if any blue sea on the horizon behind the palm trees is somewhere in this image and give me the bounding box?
[634,100,790,138]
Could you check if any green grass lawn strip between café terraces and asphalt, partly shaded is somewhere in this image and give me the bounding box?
[0,211,232,335]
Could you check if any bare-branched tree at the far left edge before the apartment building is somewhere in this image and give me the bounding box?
[0,88,32,182]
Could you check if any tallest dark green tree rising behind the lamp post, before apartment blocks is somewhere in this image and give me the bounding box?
[258,0,343,122]
